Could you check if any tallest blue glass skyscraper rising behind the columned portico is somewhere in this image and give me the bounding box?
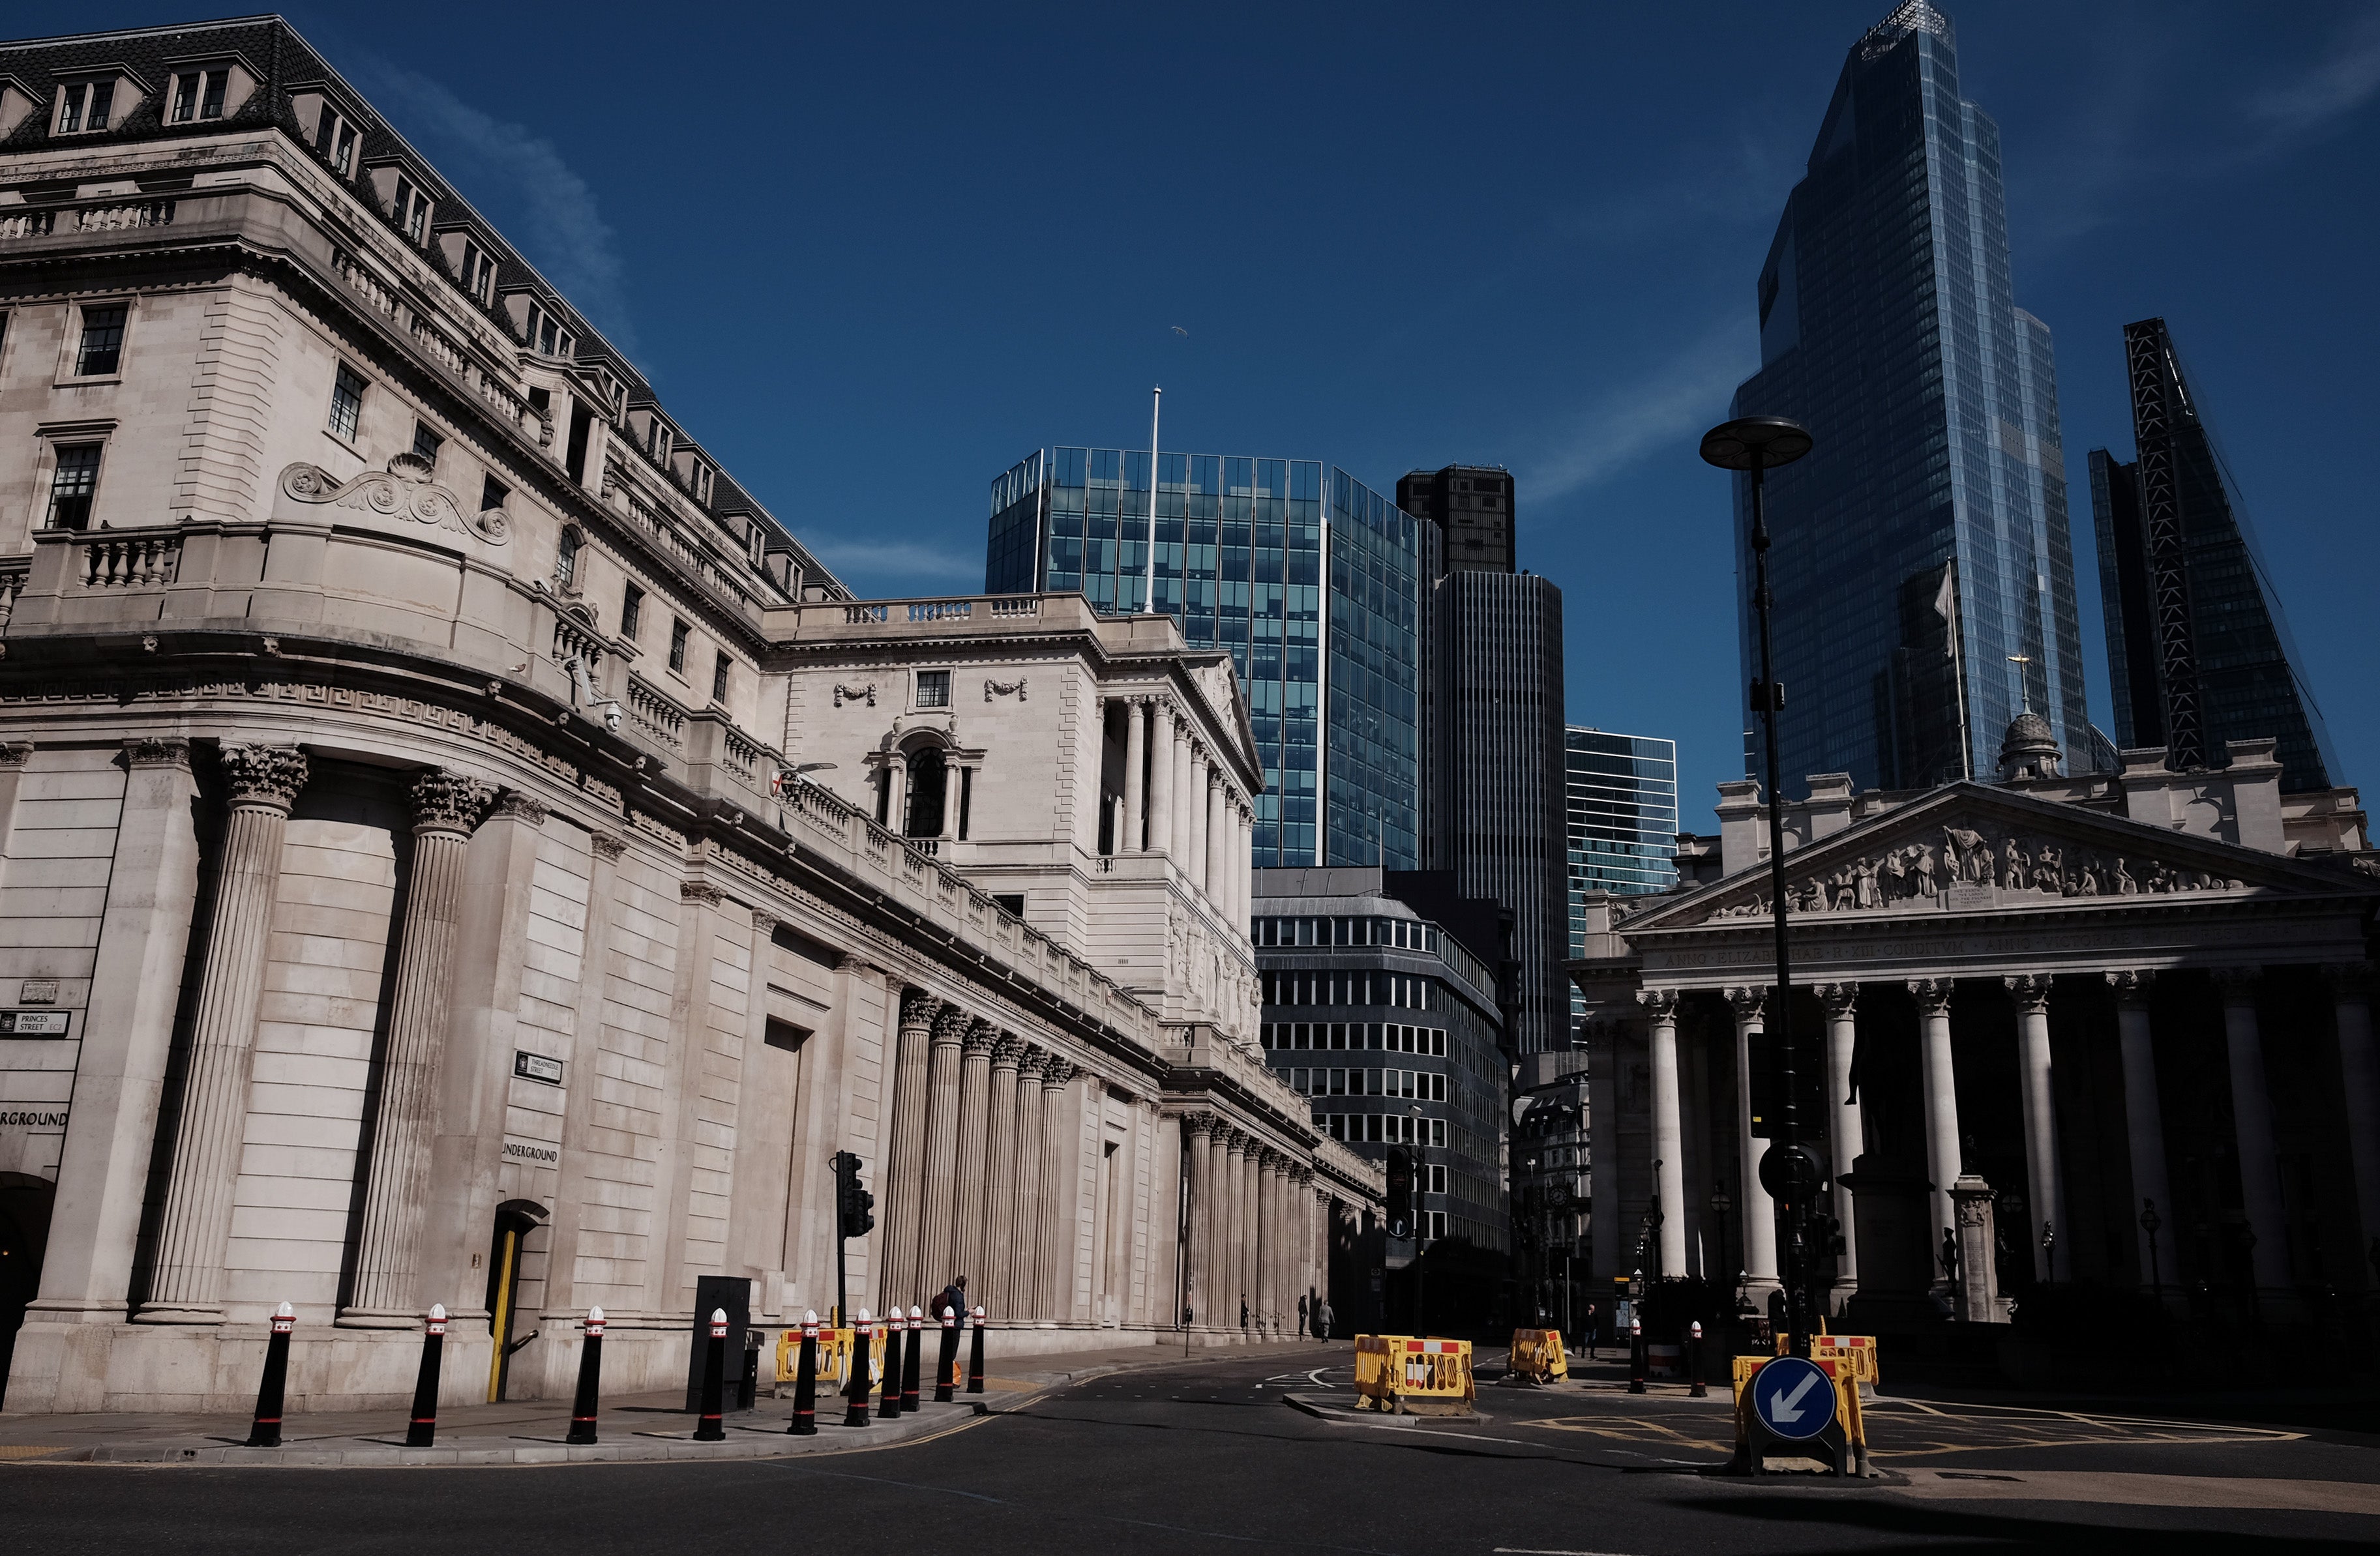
[1735,0,2090,787]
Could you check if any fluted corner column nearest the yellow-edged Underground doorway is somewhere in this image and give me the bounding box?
[340,769,502,1330]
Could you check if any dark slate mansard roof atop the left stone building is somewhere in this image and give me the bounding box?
[0,14,850,600]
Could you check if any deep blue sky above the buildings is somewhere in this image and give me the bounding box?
[37,0,2380,830]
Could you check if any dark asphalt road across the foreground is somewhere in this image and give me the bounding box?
[0,1349,2380,1556]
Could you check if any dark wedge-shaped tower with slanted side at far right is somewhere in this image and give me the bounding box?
[2090,319,2340,790]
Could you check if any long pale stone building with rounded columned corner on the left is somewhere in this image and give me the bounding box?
[0,19,1380,1411]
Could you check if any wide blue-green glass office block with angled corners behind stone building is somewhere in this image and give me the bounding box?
[983,447,1431,871]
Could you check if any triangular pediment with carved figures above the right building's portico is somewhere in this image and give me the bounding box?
[1614,783,2373,935]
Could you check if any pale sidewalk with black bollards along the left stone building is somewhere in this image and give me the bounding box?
[0,1344,1335,1468]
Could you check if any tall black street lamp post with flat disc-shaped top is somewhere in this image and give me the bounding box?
[1702,417,1823,1356]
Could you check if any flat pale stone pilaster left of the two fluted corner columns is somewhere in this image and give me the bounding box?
[26,735,200,1370]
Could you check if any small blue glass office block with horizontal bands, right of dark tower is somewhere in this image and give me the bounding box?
[1564,724,1678,1016]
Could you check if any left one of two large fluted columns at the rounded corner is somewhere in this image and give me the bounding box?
[140,744,307,1323]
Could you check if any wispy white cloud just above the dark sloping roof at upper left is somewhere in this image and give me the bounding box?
[378,66,636,355]
